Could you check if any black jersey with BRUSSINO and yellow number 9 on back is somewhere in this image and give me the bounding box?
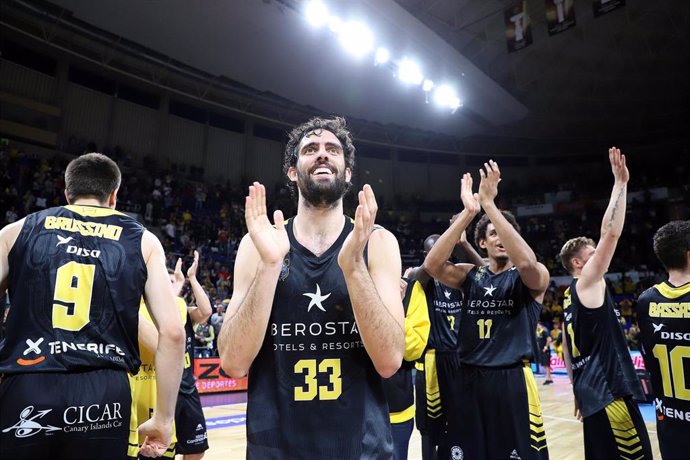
[0,205,147,374]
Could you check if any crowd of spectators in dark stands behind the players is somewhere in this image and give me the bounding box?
[0,140,690,356]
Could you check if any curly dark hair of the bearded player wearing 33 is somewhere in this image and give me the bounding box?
[283,116,356,196]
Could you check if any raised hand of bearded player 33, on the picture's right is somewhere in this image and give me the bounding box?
[338,184,378,272]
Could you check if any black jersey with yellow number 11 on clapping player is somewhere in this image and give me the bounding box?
[459,266,542,367]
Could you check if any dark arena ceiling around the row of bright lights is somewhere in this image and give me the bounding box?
[13,0,690,153]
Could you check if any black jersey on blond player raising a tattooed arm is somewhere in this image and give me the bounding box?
[563,279,644,417]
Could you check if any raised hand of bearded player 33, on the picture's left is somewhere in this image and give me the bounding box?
[244,182,290,265]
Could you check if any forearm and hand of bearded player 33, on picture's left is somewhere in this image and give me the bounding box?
[218,182,290,377]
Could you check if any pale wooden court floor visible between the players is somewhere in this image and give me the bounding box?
[204,376,661,460]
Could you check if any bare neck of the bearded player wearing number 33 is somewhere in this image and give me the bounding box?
[292,208,345,256]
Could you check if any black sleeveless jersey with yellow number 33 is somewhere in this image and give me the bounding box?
[247,217,393,460]
